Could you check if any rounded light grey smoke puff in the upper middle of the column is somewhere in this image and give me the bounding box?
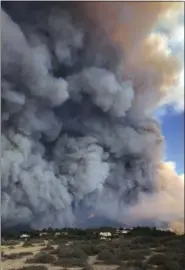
[70,67,134,117]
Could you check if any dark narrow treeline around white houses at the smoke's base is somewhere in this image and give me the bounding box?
[1,227,178,240]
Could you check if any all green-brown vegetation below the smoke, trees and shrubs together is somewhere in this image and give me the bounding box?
[1,227,185,270]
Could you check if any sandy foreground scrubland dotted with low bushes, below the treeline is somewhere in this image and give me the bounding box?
[1,234,184,270]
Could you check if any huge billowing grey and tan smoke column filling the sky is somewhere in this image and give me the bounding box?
[1,2,184,231]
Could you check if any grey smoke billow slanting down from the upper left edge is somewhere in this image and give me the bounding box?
[1,8,68,105]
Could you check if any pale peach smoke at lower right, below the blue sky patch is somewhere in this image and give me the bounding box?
[129,161,184,222]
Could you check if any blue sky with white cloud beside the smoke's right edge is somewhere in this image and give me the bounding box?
[154,7,184,175]
